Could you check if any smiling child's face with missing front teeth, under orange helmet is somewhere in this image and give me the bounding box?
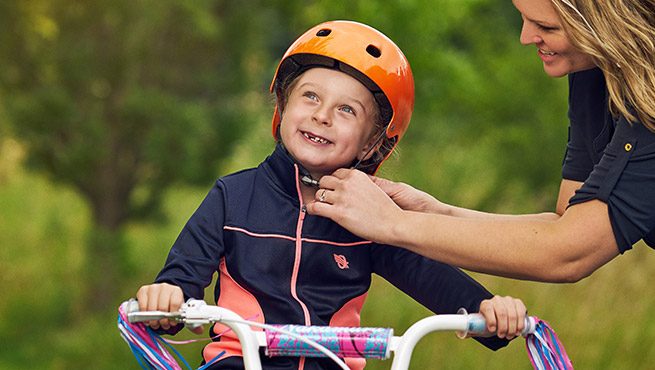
[280,68,377,179]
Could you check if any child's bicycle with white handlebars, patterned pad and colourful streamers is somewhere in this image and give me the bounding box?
[118,299,573,370]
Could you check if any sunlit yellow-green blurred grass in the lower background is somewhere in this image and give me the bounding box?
[0,140,655,370]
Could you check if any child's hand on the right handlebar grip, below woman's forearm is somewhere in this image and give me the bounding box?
[480,296,528,339]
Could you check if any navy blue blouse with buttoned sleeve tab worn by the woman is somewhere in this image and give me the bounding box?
[562,68,655,253]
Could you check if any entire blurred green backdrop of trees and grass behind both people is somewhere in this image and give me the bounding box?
[0,0,655,369]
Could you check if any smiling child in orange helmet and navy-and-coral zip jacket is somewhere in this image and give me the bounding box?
[137,21,525,369]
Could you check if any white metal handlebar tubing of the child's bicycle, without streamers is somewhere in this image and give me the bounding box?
[127,299,536,370]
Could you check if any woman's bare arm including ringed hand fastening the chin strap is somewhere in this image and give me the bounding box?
[308,169,618,282]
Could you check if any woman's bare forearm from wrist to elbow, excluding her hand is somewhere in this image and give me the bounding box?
[394,200,618,282]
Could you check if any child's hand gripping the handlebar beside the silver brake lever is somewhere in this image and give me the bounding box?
[136,283,204,334]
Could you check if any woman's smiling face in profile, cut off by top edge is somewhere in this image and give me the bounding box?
[513,0,594,77]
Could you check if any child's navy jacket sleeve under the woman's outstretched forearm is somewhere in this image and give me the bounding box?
[372,245,509,351]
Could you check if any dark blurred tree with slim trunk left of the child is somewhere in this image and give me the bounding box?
[0,0,296,307]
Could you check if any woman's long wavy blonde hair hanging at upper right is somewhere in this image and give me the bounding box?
[551,0,655,131]
